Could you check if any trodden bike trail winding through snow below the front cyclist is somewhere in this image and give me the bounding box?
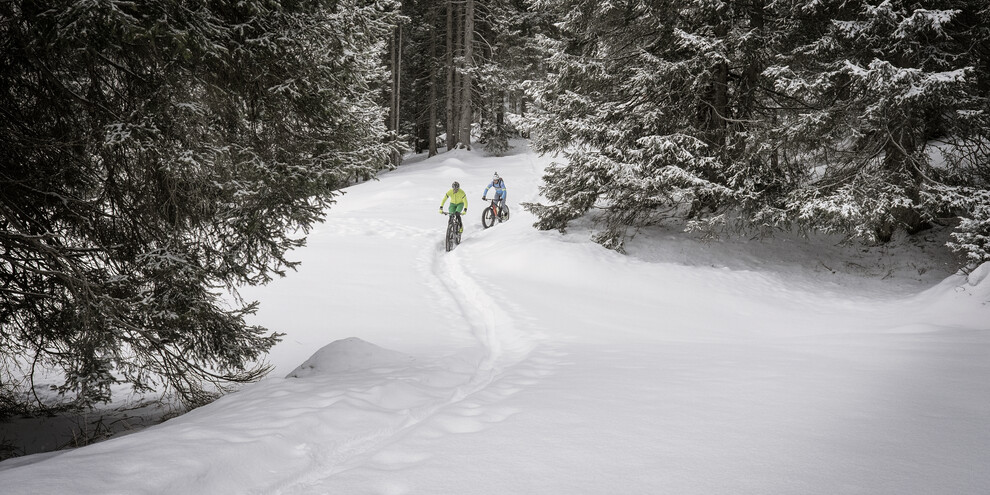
[237,154,553,494]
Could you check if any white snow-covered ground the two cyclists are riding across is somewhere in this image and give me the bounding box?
[0,142,990,495]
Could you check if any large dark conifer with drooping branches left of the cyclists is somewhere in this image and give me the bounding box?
[0,0,400,405]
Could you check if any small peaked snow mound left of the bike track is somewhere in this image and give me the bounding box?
[286,337,414,378]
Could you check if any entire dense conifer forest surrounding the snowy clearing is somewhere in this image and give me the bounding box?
[0,0,990,417]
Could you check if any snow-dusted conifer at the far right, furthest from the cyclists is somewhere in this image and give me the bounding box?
[771,1,986,242]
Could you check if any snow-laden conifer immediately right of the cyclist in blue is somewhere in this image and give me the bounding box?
[528,0,789,249]
